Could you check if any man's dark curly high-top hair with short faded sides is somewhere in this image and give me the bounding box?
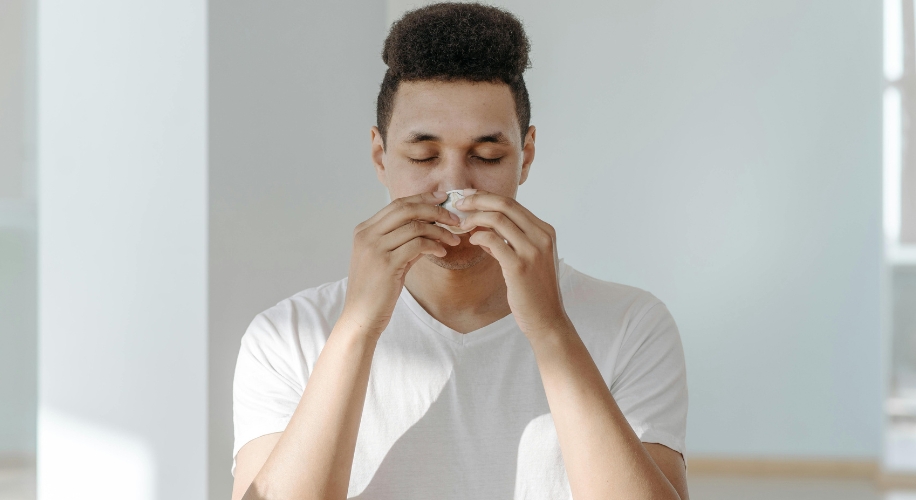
[376,2,531,147]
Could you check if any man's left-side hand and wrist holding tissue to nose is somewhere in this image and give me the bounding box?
[341,191,461,336]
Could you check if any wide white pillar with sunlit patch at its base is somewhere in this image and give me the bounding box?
[38,0,207,500]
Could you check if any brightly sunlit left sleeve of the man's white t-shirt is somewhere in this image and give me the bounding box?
[232,313,307,474]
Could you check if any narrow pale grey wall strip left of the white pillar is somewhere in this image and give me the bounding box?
[0,0,38,462]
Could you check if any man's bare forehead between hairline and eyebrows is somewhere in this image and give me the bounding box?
[388,80,520,141]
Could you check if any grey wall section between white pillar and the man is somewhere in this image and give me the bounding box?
[209,0,386,500]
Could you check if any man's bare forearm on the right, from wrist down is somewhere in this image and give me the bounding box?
[531,324,679,500]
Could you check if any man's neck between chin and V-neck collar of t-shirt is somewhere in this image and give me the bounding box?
[404,255,511,333]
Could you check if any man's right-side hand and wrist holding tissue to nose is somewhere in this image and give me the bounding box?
[455,191,571,339]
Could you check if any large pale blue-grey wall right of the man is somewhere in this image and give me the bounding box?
[389,0,883,458]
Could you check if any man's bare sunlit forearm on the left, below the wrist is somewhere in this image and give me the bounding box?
[243,320,377,500]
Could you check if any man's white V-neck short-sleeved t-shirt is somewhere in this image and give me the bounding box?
[233,261,687,500]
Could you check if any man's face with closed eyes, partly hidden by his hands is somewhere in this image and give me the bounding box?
[372,81,535,269]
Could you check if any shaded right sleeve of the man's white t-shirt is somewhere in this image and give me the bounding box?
[611,297,687,454]
